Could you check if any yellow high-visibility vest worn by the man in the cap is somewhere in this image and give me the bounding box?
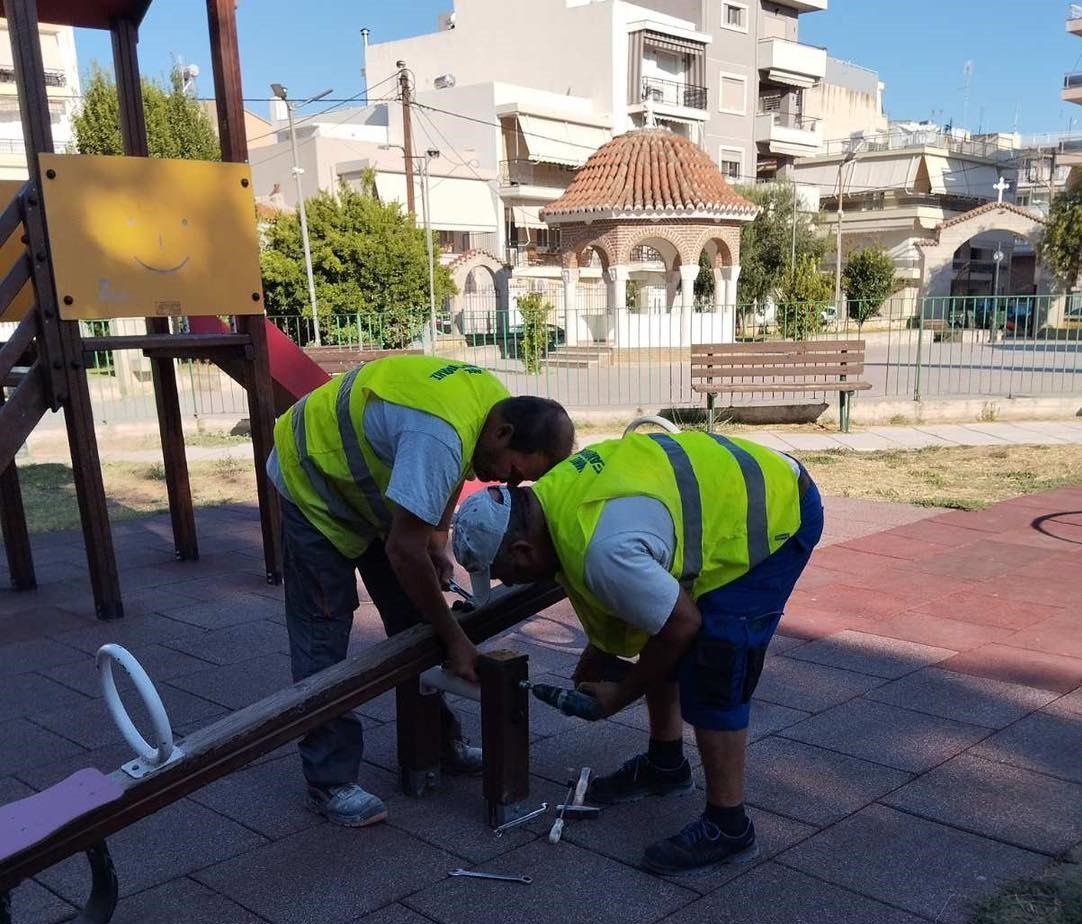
[533,432,801,658]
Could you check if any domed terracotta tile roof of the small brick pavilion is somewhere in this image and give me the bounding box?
[541,129,757,221]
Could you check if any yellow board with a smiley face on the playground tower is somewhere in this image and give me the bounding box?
[40,154,263,320]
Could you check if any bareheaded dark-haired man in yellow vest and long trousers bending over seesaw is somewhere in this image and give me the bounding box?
[267,356,575,827]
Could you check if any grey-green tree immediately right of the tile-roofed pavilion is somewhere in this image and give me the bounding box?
[737,183,826,306]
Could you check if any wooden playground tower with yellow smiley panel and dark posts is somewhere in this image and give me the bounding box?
[0,0,288,619]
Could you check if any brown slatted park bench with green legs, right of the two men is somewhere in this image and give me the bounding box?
[691,340,871,433]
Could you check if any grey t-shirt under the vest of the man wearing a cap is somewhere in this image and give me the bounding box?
[584,452,800,635]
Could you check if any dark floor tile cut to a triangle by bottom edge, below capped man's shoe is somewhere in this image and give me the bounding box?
[658,863,923,924]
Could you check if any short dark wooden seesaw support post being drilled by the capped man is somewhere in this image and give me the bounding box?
[477,651,530,827]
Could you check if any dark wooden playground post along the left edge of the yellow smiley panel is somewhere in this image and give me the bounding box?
[4,0,123,619]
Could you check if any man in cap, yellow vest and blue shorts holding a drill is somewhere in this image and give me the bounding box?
[452,433,823,874]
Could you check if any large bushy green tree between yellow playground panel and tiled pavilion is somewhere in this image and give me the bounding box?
[261,182,457,348]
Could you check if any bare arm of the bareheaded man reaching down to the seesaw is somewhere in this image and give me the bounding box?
[386,507,477,682]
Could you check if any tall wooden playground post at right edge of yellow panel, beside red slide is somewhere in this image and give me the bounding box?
[207,0,281,584]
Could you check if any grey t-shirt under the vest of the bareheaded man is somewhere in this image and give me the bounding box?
[267,398,462,526]
